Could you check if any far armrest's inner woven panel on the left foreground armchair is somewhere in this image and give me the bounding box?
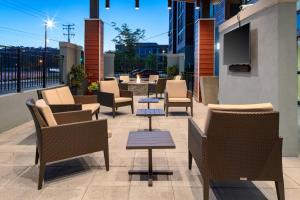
[53,110,93,125]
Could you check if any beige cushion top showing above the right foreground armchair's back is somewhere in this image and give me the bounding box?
[208,103,273,112]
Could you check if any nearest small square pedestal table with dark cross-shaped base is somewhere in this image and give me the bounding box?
[126,131,176,187]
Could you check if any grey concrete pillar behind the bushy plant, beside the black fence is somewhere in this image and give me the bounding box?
[59,42,82,83]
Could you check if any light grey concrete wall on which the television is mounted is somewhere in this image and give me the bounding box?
[219,0,299,156]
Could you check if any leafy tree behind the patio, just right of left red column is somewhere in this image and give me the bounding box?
[112,23,145,72]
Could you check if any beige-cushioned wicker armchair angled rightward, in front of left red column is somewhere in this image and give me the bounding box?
[98,81,134,118]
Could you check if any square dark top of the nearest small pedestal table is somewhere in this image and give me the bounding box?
[126,131,176,149]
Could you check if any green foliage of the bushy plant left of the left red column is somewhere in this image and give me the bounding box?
[69,65,86,87]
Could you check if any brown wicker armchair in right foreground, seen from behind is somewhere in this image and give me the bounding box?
[188,104,285,200]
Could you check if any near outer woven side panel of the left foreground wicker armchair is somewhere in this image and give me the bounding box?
[40,120,108,162]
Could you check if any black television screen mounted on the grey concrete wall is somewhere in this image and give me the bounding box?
[224,24,251,65]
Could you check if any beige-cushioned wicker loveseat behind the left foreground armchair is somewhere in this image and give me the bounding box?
[37,86,100,119]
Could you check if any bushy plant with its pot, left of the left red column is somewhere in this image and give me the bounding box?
[69,65,87,95]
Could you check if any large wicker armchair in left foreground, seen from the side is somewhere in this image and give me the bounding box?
[26,99,111,189]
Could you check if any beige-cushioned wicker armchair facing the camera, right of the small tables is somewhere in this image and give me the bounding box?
[164,80,193,116]
